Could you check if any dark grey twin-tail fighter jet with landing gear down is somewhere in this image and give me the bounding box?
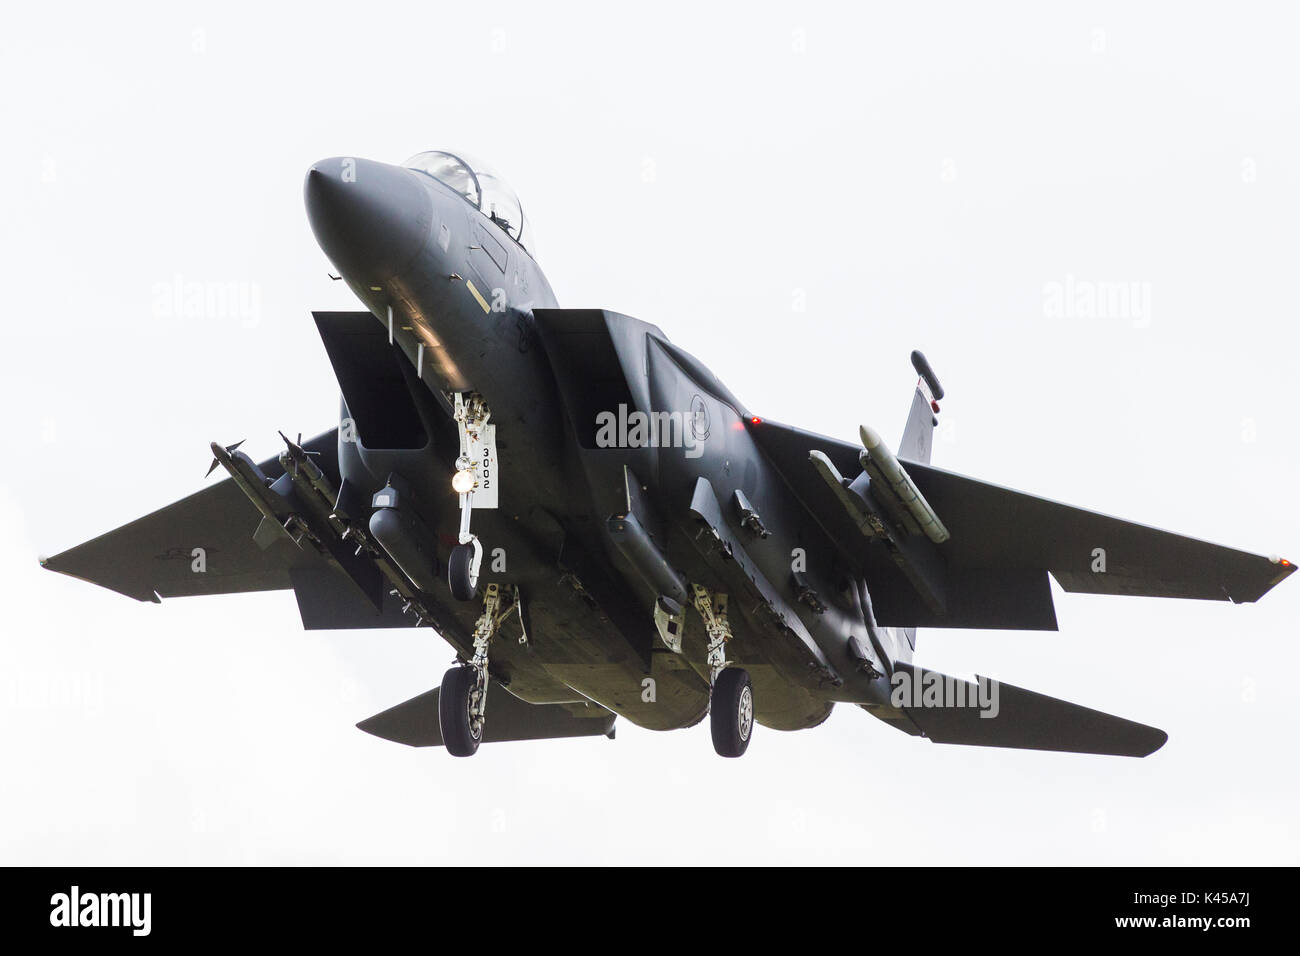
[43,150,1295,757]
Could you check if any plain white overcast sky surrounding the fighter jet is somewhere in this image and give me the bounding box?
[0,3,1300,865]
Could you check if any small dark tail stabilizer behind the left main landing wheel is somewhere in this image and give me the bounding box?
[356,680,614,747]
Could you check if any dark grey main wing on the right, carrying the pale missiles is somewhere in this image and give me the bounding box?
[751,420,1295,613]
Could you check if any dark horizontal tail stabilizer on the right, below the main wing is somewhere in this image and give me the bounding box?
[896,663,1169,757]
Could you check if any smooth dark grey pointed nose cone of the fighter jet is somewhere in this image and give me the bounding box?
[303,156,433,282]
